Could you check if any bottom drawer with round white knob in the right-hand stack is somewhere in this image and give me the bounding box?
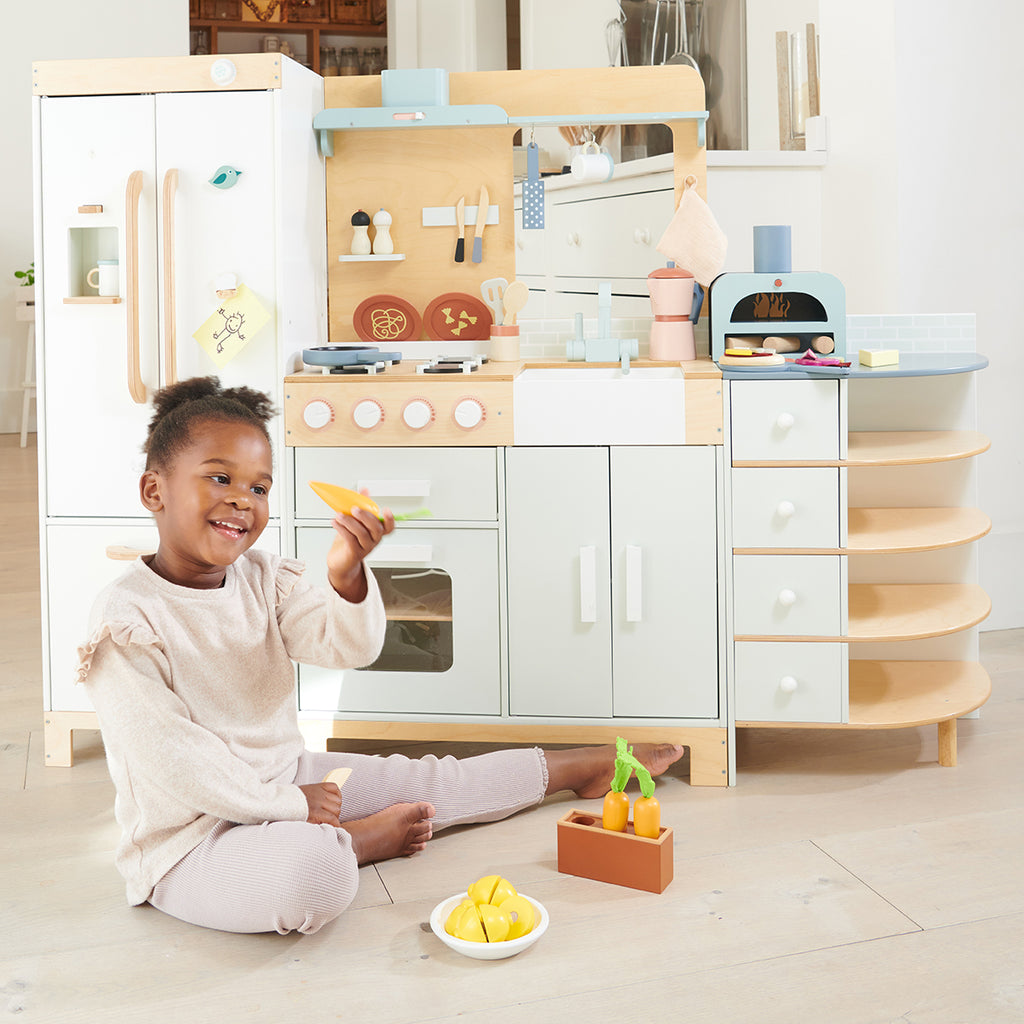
[735,643,848,723]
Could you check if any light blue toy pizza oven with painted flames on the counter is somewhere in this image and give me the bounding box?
[709,272,846,366]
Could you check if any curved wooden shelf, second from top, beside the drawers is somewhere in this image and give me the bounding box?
[846,508,992,555]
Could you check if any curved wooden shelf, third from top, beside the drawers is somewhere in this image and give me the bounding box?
[847,583,992,643]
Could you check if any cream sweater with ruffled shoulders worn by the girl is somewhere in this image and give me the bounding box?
[78,550,385,904]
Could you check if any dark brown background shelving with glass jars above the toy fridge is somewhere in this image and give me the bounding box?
[189,0,387,75]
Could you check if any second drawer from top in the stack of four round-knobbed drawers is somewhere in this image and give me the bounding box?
[732,467,846,548]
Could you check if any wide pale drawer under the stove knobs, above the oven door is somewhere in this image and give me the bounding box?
[294,447,498,522]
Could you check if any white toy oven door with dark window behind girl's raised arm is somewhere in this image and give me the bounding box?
[295,526,501,716]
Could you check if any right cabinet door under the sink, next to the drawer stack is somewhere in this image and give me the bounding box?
[611,446,718,718]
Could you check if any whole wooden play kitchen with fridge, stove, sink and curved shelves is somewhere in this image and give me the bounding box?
[35,54,990,782]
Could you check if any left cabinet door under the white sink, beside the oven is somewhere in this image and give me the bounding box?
[506,447,611,718]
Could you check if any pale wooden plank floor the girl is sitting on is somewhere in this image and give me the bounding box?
[0,435,1024,1024]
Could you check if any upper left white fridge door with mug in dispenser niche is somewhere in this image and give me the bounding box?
[39,96,158,516]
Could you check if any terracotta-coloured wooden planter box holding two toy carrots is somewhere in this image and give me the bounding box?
[558,811,673,893]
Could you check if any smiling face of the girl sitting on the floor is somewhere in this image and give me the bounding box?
[139,420,273,588]
